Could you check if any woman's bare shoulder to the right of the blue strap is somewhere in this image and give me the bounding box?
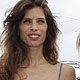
[61,64,76,80]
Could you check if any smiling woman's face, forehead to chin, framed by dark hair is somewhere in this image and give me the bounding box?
[20,7,48,47]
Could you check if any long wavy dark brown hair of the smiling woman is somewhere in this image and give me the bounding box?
[0,0,60,80]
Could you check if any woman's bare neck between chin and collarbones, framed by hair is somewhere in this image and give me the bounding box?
[29,47,47,67]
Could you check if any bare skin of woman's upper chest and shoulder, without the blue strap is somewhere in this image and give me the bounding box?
[15,63,76,80]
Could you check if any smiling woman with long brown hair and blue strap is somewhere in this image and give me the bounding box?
[0,0,76,80]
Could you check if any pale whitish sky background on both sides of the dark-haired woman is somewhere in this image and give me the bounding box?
[0,0,80,80]
